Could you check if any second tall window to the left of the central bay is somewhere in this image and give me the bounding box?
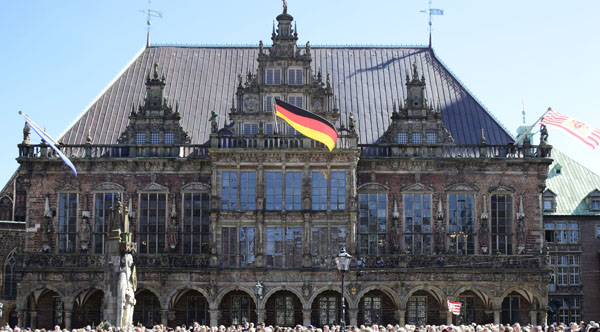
[138,193,167,254]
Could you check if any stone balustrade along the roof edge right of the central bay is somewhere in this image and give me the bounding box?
[358,144,550,158]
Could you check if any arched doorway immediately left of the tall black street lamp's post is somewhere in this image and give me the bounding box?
[310,290,350,327]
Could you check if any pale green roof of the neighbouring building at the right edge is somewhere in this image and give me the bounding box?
[544,148,600,216]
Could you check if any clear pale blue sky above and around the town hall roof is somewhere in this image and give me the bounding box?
[0,0,600,186]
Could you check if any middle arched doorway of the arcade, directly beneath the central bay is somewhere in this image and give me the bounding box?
[265,291,302,326]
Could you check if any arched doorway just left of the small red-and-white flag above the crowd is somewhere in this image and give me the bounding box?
[406,290,447,325]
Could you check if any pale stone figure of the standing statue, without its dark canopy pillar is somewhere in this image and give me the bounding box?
[117,254,136,327]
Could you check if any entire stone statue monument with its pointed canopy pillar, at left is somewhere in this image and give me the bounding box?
[103,198,137,328]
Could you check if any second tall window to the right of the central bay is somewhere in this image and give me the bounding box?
[404,194,431,255]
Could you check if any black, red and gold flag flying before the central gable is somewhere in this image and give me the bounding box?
[275,99,337,151]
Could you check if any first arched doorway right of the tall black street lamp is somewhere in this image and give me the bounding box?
[358,290,398,325]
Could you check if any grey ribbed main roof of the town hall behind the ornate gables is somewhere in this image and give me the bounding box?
[62,46,513,144]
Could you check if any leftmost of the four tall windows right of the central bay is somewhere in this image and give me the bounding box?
[358,193,387,256]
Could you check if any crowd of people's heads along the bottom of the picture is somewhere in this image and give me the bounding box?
[2,321,600,332]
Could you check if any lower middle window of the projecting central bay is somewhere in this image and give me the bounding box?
[265,227,302,267]
